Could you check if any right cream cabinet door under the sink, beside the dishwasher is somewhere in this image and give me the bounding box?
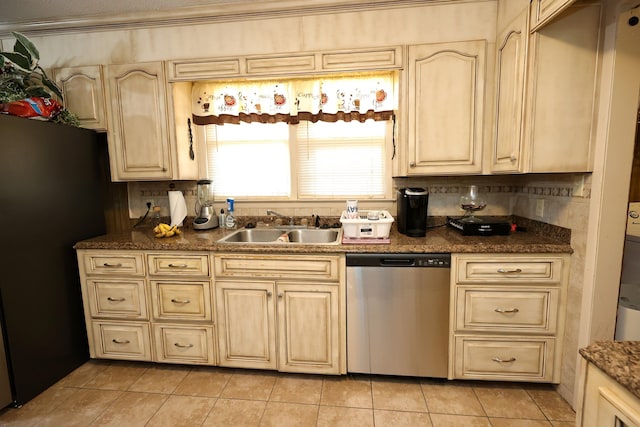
[278,283,340,374]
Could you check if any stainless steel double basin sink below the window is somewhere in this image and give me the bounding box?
[218,227,342,245]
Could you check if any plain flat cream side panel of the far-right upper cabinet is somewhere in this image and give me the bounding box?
[523,2,602,172]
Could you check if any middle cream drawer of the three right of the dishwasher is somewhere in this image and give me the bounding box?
[456,287,559,334]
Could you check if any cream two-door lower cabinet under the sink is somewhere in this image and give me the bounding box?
[214,254,346,374]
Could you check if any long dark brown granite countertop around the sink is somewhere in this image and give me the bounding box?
[74,217,572,253]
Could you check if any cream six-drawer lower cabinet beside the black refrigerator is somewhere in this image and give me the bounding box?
[78,250,216,365]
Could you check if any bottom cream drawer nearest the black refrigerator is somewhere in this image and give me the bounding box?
[93,322,151,361]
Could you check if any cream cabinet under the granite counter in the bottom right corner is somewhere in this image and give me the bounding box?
[576,360,640,427]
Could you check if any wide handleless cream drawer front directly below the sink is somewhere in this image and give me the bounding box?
[214,254,340,281]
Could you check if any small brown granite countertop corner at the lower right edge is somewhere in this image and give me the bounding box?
[580,341,640,398]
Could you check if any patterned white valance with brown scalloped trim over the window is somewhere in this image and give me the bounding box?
[192,72,397,125]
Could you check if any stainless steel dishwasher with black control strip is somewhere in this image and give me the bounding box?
[346,254,451,378]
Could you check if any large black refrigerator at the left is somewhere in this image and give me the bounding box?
[0,115,106,407]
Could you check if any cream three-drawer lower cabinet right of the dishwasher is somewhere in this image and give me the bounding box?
[449,254,569,383]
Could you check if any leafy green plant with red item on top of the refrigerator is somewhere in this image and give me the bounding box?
[0,32,80,126]
